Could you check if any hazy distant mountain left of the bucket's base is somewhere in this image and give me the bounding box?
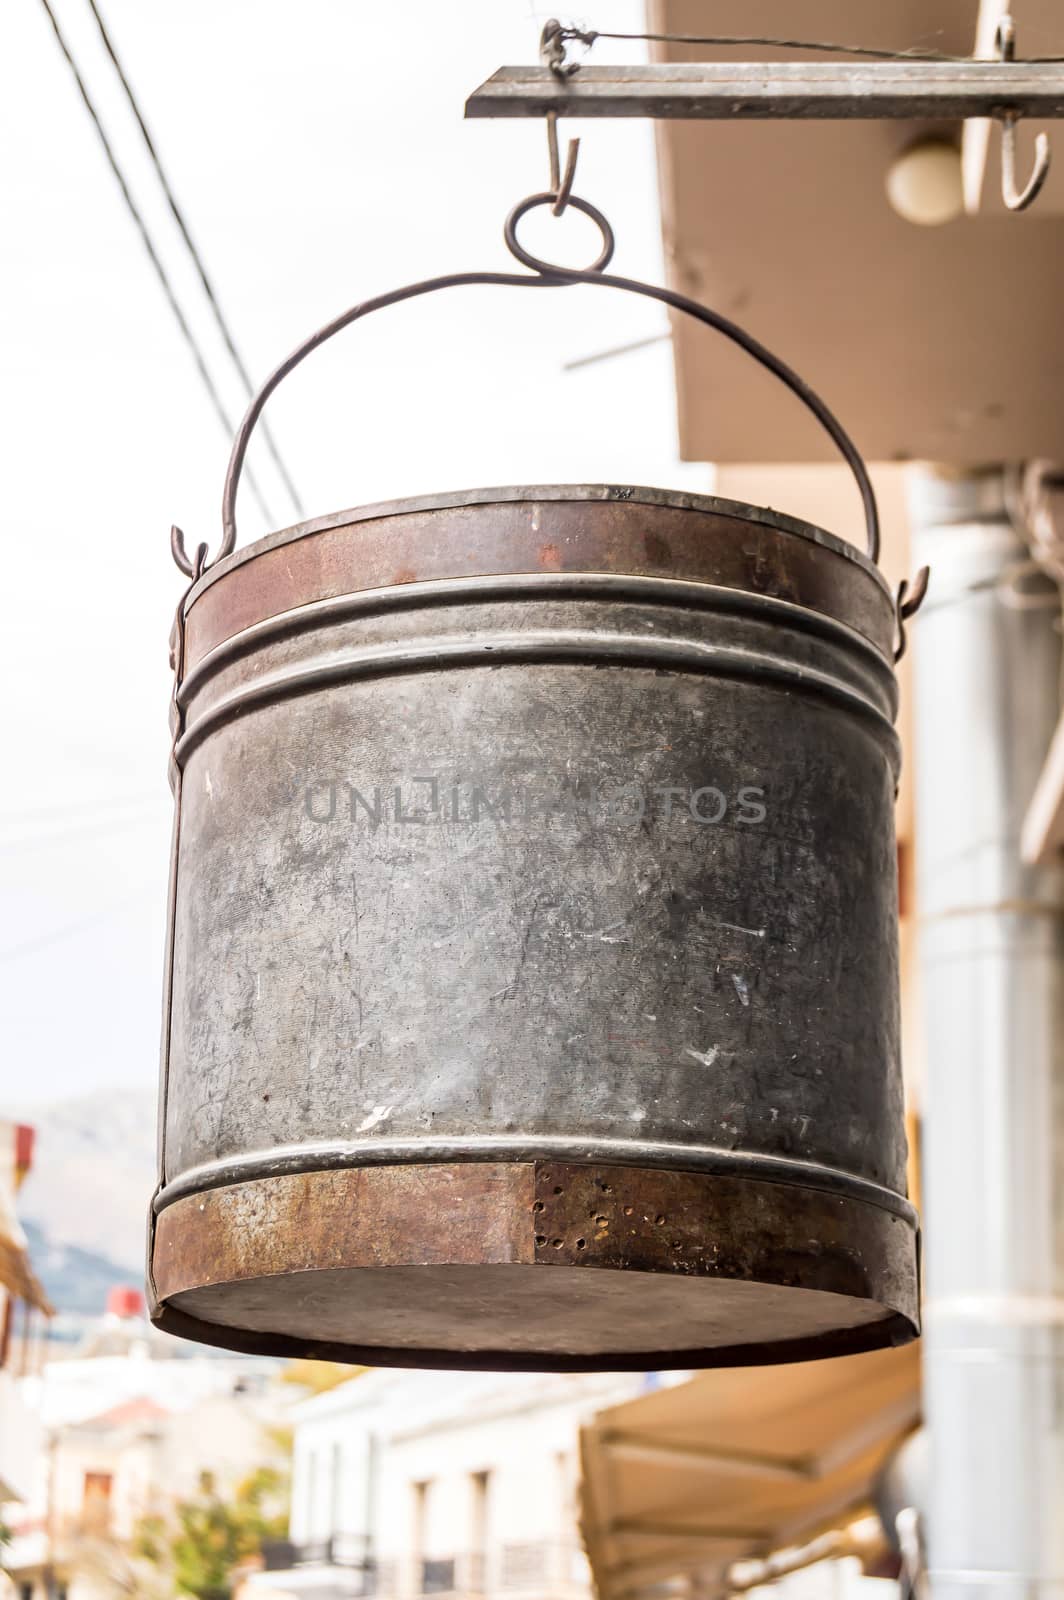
[18,1090,155,1312]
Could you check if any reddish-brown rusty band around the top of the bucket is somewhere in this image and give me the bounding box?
[178,485,898,667]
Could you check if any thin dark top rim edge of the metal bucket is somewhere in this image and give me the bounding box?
[184,483,894,613]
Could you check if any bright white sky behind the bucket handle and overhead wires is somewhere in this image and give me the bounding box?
[0,0,710,1110]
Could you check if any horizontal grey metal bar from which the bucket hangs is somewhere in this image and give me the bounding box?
[466,61,1064,122]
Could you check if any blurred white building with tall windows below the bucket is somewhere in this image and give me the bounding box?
[243,1370,648,1600]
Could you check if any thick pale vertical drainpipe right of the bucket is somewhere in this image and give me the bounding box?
[910,472,1064,1600]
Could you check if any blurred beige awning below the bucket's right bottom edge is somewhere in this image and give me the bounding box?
[581,1346,920,1600]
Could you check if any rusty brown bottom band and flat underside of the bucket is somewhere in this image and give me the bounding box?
[155,1162,917,1370]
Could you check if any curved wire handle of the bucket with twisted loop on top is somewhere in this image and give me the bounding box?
[171,190,880,578]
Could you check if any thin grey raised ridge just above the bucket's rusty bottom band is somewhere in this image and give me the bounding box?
[155,1134,918,1230]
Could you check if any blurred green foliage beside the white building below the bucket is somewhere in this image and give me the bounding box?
[136,1467,288,1600]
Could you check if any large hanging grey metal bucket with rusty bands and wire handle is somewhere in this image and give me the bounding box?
[149,202,918,1368]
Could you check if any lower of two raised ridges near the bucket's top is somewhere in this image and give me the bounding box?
[174,629,901,776]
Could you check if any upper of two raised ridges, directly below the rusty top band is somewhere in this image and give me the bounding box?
[179,573,898,707]
